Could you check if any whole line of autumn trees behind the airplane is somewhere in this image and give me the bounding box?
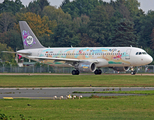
[0,0,154,63]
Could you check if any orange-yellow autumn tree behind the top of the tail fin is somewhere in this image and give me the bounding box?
[15,12,56,36]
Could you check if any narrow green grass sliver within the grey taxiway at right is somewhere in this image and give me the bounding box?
[73,90,154,95]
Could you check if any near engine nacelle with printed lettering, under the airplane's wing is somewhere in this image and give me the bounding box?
[75,61,96,72]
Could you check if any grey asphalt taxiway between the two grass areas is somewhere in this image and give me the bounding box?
[0,87,154,99]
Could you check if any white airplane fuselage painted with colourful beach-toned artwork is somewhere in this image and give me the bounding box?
[18,47,153,68]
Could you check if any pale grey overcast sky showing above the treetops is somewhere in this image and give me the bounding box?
[0,0,154,13]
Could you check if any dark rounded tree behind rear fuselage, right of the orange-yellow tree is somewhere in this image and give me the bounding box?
[51,19,79,47]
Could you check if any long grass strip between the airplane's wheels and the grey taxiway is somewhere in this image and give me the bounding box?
[0,75,154,87]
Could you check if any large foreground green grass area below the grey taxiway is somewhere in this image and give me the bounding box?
[0,95,154,120]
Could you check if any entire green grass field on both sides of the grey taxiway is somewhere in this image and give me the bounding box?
[0,75,154,120]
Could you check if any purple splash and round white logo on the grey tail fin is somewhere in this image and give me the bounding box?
[22,30,36,47]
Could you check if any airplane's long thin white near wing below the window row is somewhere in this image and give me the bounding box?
[29,56,80,62]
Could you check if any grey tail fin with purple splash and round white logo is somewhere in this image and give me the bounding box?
[19,21,44,49]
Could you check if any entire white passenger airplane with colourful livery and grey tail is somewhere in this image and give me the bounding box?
[3,21,153,75]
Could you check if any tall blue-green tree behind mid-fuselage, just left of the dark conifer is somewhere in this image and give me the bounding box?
[88,5,110,46]
